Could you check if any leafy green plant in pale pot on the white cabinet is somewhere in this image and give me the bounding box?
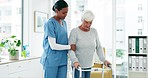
[0,35,21,60]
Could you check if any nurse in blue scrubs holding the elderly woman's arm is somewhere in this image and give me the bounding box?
[40,0,76,78]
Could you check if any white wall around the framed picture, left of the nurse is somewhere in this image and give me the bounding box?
[23,0,50,56]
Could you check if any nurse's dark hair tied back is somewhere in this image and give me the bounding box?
[52,0,68,11]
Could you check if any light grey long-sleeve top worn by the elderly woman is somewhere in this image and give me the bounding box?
[68,27,105,68]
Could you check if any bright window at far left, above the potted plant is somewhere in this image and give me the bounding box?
[0,0,22,53]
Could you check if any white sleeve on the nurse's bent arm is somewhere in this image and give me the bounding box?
[48,37,70,50]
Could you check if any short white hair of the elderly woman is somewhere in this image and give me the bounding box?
[82,10,95,21]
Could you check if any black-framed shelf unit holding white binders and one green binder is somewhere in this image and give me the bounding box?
[128,36,148,78]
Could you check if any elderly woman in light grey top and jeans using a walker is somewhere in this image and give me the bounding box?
[68,11,110,78]
